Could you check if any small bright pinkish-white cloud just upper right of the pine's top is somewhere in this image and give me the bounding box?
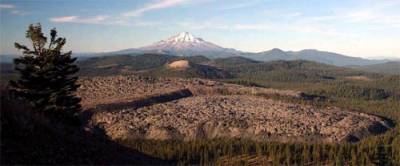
[50,15,108,24]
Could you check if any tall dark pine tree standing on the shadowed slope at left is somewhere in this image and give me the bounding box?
[10,24,81,123]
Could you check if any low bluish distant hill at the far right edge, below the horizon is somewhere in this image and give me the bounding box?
[353,61,400,74]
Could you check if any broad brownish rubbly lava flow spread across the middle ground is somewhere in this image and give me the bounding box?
[79,77,389,142]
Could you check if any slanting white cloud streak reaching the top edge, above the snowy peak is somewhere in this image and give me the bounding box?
[122,0,189,17]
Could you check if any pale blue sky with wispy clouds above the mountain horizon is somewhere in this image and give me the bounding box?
[0,0,400,59]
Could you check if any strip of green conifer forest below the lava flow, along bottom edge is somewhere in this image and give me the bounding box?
[121,136,399,165]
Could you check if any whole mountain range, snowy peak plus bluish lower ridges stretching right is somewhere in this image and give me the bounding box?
[105,32,387,66]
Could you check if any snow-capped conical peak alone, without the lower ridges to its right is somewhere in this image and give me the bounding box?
[115,32,241,58]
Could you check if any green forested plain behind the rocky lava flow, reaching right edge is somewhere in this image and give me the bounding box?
[223,61,400,100]
